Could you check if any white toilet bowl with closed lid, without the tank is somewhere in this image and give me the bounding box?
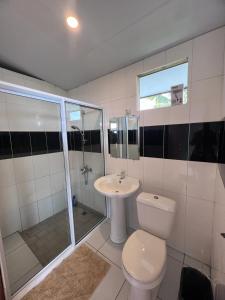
[122,230,166,300]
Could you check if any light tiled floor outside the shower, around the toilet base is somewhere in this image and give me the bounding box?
[86,222,210,300]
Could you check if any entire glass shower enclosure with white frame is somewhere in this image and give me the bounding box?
[0,82,106,297]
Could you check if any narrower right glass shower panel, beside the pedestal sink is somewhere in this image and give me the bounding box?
[66,102,106,242]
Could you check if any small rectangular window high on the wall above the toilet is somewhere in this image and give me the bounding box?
[139,62,188,110]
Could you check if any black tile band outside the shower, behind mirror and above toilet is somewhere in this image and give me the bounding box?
[108,121,225,164]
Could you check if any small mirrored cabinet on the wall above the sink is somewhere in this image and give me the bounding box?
[108,115,139,160]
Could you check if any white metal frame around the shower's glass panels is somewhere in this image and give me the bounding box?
[0,80,107,300]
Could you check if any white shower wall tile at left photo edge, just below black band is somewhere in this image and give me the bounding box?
[0,159,15,187]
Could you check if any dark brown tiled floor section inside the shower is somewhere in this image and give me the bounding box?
[20,205,104,267]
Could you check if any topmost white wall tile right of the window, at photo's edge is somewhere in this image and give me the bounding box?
[192,27,225,81]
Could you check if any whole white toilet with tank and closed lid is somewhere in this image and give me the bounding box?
[122,193,176,300]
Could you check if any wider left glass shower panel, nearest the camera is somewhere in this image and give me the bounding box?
[0,92,71,294]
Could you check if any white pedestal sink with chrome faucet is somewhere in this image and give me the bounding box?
[94,174,140,244]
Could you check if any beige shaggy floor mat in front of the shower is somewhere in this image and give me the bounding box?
[23,245,110,300]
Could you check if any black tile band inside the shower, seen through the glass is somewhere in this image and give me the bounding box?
[0,130,102,160]
